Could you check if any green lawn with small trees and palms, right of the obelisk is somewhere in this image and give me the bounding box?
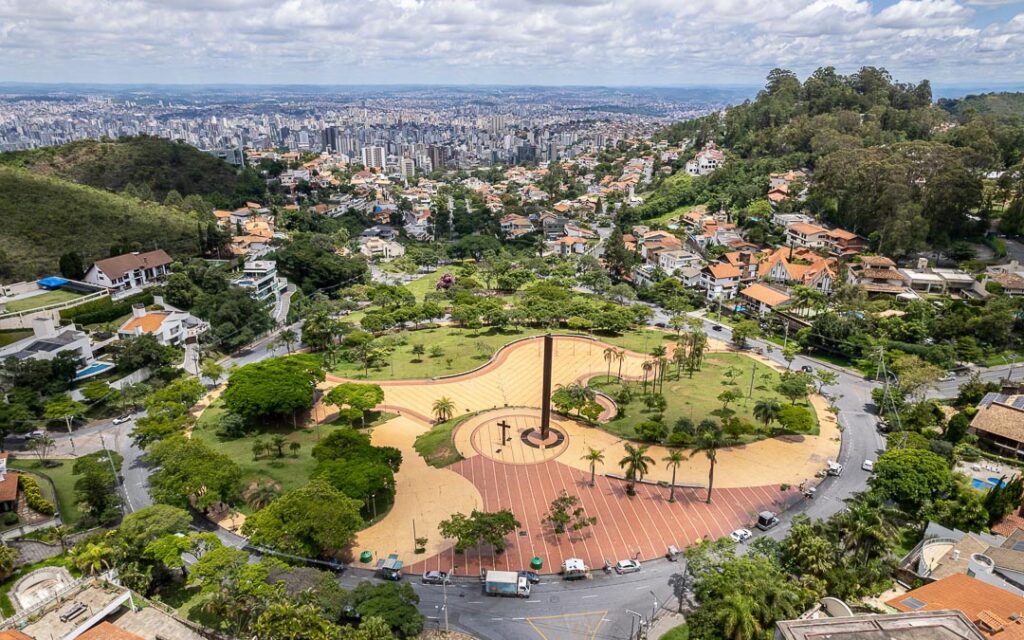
[592,353,817,438]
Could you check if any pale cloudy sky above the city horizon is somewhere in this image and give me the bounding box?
[0,0,1024,86]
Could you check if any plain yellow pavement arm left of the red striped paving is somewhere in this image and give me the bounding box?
[352,416,483,563]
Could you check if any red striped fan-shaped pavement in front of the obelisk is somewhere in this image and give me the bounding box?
[409,456,792,575]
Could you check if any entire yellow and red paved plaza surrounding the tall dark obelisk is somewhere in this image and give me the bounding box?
[323,337,839,574]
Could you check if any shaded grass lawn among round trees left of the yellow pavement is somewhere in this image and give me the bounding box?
[191,399,394,513]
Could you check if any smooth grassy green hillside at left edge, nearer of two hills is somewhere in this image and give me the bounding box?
[0,166,198,280]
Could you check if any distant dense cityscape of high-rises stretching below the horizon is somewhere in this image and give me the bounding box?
[0,86,751,172]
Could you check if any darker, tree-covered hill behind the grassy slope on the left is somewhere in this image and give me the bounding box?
[0,136,239,201]
